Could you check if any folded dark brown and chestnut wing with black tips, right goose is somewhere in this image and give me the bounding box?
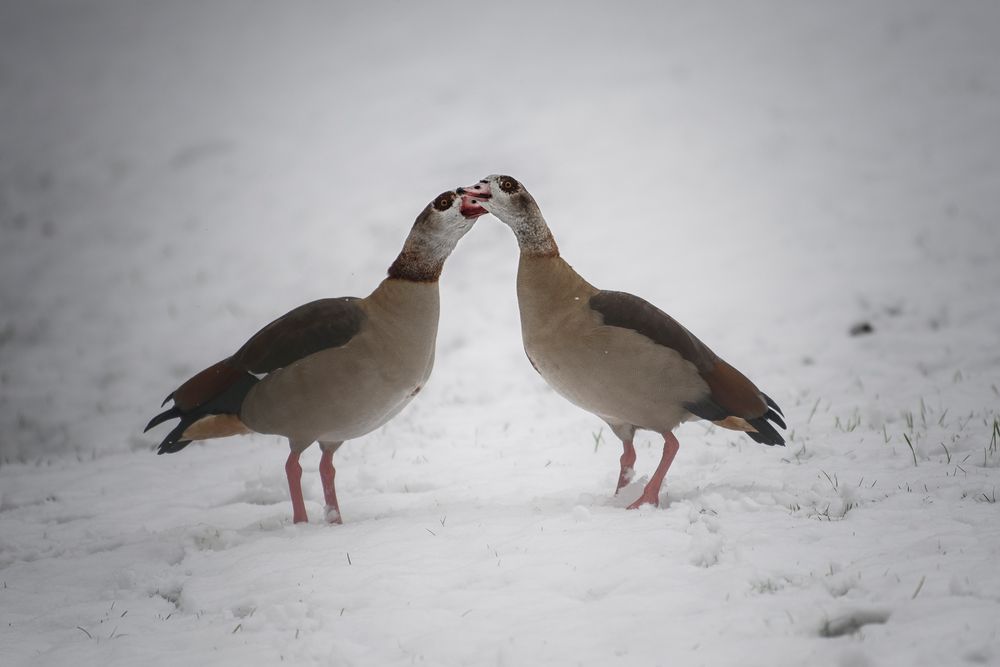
[590,291,785,445]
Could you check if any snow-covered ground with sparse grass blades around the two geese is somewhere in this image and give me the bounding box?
[0,0,1000,667]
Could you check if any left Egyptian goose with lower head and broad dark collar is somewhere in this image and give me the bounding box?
[146,192,486,523]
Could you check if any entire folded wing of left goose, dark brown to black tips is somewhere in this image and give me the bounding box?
[145,297,365,454]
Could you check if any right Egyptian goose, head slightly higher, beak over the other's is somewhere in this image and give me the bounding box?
[457,175,785,509]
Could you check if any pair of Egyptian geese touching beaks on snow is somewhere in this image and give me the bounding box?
[146,175,785,523]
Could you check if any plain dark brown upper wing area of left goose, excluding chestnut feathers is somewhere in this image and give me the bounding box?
[231,297,365,375]
